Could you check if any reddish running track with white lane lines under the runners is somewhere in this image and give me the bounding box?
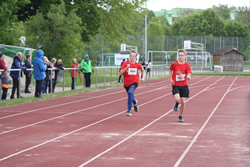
[0,76,250,167]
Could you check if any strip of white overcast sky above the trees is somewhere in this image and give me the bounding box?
[147,0,250,11]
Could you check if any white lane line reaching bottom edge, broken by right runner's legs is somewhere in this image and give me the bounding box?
[79,77,224,167]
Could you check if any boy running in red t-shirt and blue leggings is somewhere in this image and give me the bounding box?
[120,49,144,116]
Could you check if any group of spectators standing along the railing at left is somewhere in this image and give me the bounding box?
[0,49,92,100]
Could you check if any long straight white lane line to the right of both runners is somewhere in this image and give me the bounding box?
[174,77,237,167]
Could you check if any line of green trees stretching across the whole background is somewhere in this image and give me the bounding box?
[0,0,250,64]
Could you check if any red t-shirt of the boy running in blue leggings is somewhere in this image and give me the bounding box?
[121,61,142,87]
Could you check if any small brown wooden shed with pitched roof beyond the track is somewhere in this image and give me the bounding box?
[212,49,245,71]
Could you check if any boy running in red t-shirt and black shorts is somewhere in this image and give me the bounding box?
[169,49,192,122]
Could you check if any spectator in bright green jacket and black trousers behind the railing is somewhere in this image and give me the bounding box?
[81,54,92,87]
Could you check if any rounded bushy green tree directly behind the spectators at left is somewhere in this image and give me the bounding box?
[26,2,84,65]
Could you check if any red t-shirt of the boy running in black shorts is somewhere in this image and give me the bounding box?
[169,61,192,86]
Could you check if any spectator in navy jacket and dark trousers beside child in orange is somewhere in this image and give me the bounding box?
[10,52,26,99]
